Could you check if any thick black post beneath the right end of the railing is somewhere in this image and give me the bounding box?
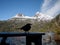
[26,35,42,45]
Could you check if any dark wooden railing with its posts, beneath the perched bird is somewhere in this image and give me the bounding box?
[0,32,45,45]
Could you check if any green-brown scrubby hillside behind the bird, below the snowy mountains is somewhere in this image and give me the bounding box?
[0,14,60,33]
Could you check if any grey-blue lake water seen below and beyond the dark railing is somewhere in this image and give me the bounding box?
[0,36,56,45]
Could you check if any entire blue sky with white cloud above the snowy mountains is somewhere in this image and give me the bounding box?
[0,0,60,20]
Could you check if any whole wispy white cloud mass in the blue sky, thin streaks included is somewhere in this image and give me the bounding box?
[41,0,60,16]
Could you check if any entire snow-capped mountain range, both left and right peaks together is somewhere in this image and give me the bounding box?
[10,12,53,21]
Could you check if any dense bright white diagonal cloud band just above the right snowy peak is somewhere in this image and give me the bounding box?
[46,1,60,16]
